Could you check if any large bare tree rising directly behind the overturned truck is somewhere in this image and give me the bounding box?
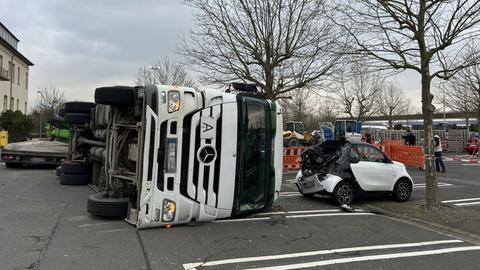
[181,0,342,99]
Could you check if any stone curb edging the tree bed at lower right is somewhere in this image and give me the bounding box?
[362,204,480,245]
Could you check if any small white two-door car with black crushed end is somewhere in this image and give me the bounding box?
[296,141,413,205]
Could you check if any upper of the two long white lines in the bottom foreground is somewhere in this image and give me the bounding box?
[183,239,463,270]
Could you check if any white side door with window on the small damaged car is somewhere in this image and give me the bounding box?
[350,144,394,191]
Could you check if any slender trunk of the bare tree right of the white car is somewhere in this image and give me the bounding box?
[422,72,439,209]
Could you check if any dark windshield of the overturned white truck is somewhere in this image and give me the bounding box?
[237,97,272,213]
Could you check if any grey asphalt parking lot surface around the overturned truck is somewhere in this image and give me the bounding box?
[0,161,480,270]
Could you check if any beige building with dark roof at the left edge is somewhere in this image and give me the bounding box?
[0,22,33,113]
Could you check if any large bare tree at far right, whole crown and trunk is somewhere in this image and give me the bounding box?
[332,0,480,209]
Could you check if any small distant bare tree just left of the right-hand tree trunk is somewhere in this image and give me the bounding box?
[379,83,410,129]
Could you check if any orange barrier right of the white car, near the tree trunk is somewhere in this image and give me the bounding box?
[384,145,425,170]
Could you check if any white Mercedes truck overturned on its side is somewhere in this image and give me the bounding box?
[62,84,282,228]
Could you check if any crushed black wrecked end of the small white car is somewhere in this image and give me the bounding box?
[300,141,353,178]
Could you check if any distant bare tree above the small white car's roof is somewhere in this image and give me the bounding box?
[337,62,384,121]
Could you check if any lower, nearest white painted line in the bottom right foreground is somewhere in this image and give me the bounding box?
[246,246,480,270]
